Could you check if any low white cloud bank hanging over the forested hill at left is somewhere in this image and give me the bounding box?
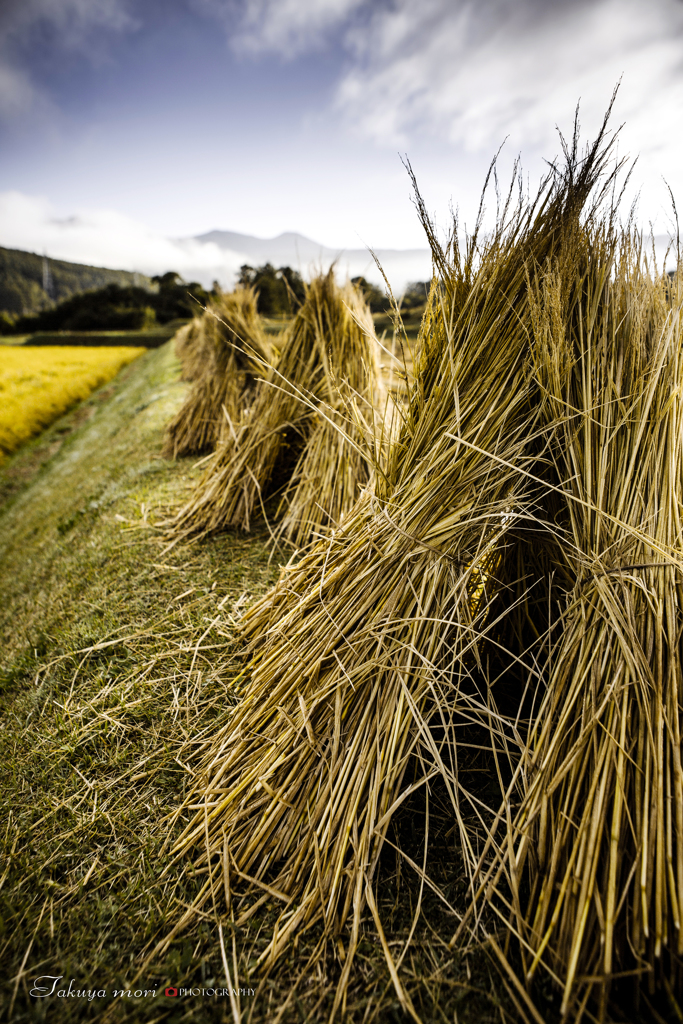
[0,191,248,287]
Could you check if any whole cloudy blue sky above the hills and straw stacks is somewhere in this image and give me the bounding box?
[0,0,683,280]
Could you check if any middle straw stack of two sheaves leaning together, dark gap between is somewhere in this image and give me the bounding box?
[163,270,380,545]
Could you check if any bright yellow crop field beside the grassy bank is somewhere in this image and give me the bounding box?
[0,345,145,459]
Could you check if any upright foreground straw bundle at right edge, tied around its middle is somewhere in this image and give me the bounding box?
[483,228,683,1021]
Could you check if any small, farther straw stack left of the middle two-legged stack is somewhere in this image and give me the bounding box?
[164,288,273,458]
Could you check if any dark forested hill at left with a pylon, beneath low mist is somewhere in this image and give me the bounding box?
[0,247,151,315]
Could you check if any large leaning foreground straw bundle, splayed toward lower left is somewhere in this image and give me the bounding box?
[172,116,609,1010]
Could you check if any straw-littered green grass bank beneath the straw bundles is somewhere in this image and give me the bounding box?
[0,345,514,1024]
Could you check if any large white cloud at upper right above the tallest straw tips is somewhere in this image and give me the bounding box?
[201,0,683,214]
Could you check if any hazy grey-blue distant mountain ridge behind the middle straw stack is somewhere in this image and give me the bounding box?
[193,230,431,291]
